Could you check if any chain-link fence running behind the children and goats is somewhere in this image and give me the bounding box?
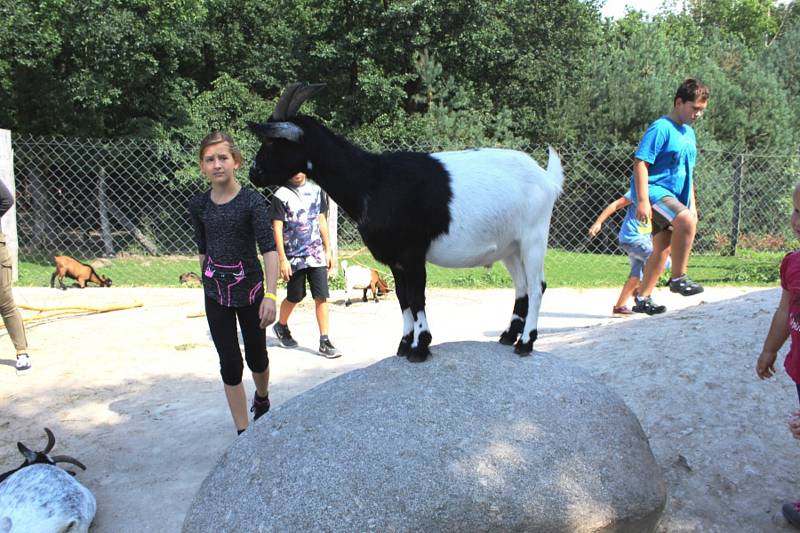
[7,136,800,279]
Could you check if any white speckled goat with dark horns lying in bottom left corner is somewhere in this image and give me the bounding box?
[0,428,97,533]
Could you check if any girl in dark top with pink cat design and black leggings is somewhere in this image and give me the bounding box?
[189,132,278,433]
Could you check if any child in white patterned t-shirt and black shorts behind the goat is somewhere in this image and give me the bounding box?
[269,172,342,359]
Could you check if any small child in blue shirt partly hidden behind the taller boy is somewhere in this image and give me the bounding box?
[589,190,669,316]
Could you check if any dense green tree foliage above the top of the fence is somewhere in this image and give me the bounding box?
[0,0,800,158]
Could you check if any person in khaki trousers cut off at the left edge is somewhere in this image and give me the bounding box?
[0,181,31,375]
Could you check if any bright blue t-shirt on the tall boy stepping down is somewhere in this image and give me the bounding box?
[631,116,697,207]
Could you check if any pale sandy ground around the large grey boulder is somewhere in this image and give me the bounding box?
[0,288,800,533]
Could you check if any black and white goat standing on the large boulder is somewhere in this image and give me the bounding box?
[249,83,564,362]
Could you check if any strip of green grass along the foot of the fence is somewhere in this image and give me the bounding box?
[17,250,784,289]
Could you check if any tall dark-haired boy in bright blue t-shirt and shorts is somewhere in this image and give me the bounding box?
[631,78,710,315]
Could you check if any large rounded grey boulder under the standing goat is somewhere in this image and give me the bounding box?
[183,342,666,532]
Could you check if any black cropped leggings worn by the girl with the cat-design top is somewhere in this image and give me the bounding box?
[206,295,269,387]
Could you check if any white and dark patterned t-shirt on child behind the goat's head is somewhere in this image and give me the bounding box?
[269,180,328,272]
